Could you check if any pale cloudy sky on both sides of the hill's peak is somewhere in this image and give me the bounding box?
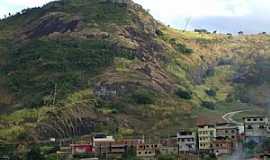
[0,0,270,33]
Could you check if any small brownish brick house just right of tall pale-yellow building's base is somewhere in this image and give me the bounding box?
[211,137,233,156]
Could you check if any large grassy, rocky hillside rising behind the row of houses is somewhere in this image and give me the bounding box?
[0,0,270,142]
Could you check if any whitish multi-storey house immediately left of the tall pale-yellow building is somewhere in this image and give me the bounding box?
[177,130,197,152]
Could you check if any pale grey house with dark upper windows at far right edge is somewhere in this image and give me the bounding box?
[243,116,270,143]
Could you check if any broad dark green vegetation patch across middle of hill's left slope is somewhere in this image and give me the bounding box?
[4,39,134,106]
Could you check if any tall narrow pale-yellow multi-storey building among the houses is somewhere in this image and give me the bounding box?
[198,124,216,152]
